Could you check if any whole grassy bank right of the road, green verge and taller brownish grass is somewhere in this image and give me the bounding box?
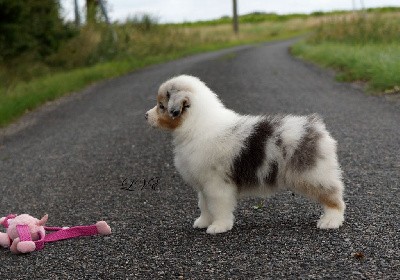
[292,8,400,93]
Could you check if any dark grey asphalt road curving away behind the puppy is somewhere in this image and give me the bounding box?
[0,41,400,279]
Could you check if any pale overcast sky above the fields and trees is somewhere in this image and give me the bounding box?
[61,0,400,23]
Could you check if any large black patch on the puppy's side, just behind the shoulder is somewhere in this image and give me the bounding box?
[231,118,278,188]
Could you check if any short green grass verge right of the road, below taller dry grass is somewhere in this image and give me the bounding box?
[292,41,400,92]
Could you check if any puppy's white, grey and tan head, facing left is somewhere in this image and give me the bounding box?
[146,76,195,130]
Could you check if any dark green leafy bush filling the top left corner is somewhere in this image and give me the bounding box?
[0,0,77,87]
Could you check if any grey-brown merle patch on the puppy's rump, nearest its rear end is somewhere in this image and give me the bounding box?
[290,121,322,171]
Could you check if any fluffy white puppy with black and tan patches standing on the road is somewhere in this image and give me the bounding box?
[146,75,345,234]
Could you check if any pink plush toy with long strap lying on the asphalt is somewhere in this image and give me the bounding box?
[0,214,111,254]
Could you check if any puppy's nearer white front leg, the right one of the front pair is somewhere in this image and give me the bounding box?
[204,183,236,234]
